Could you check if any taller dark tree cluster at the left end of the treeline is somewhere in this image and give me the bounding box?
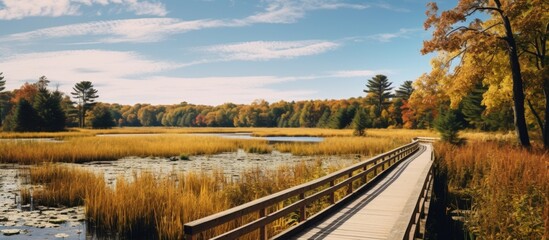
[0,73,116,132]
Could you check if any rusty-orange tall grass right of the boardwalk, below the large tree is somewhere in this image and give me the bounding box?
[435,141,549,239]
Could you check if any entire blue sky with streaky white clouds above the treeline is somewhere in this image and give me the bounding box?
[0,0,452,105]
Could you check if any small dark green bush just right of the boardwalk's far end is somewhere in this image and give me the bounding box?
[434,109,463,144]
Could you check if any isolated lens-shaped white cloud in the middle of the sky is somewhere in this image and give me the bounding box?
[204,40,339,61]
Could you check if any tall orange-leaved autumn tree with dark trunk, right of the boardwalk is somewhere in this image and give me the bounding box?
[422,0,549,147]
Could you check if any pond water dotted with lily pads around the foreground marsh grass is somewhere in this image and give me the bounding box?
[0,150,352,239]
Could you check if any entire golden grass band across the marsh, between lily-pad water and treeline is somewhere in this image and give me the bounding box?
[0,128,433,164]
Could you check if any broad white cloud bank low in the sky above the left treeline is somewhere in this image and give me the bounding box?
[0,50,384,105]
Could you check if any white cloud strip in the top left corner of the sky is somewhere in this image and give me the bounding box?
[0,0,167,20]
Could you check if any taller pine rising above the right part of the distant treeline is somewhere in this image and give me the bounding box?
[364,75,393,117]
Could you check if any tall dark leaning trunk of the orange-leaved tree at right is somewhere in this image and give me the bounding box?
[496,6,530,147]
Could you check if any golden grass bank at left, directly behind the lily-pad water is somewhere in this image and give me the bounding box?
[0,134,268,164]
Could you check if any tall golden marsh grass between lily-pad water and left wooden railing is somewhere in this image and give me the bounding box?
[21,160,354,239]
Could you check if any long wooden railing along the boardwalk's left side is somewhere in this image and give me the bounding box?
[184,139,422,239]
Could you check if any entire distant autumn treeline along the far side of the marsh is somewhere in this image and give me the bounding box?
[0,75,512,135]
